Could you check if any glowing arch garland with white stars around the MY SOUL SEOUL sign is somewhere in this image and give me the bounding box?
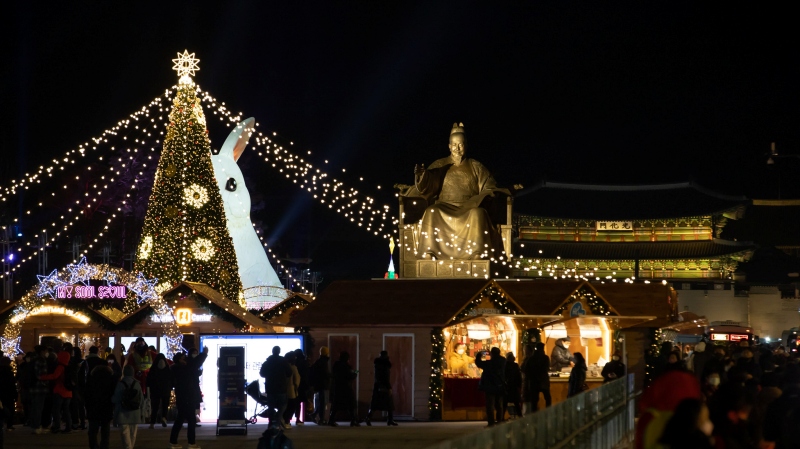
[0,257,183,360]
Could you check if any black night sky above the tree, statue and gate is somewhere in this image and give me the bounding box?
[0,2,800,290]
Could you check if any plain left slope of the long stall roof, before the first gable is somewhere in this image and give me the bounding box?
[289,279,491,327]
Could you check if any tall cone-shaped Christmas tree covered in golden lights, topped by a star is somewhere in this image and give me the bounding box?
[136,51,242,302]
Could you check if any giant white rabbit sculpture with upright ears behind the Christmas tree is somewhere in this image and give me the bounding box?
[211,117,284,302]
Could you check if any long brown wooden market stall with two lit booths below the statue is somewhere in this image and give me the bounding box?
[288,279,674,420]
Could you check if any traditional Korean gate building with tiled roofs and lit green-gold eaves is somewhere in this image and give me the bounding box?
[512,182,755,284]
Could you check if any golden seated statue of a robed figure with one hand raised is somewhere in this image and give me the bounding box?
[414,123,510,259]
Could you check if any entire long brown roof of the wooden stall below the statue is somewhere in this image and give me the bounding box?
[288,279,675,327]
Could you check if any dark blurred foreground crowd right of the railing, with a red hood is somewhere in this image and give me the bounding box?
[636,340,800,449]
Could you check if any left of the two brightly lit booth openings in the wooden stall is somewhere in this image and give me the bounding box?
[444,317,519,378]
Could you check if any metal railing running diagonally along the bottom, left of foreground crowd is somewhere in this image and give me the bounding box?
[428,374,636,449]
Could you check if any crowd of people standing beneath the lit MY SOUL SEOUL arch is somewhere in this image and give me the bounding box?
[0,338,208,449]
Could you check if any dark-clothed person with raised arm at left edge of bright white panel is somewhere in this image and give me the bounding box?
[169,346,208,449]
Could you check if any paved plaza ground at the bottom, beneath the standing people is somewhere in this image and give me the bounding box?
[5,422,486,449]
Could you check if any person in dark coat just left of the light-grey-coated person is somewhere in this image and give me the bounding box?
[85,357,117,449]
